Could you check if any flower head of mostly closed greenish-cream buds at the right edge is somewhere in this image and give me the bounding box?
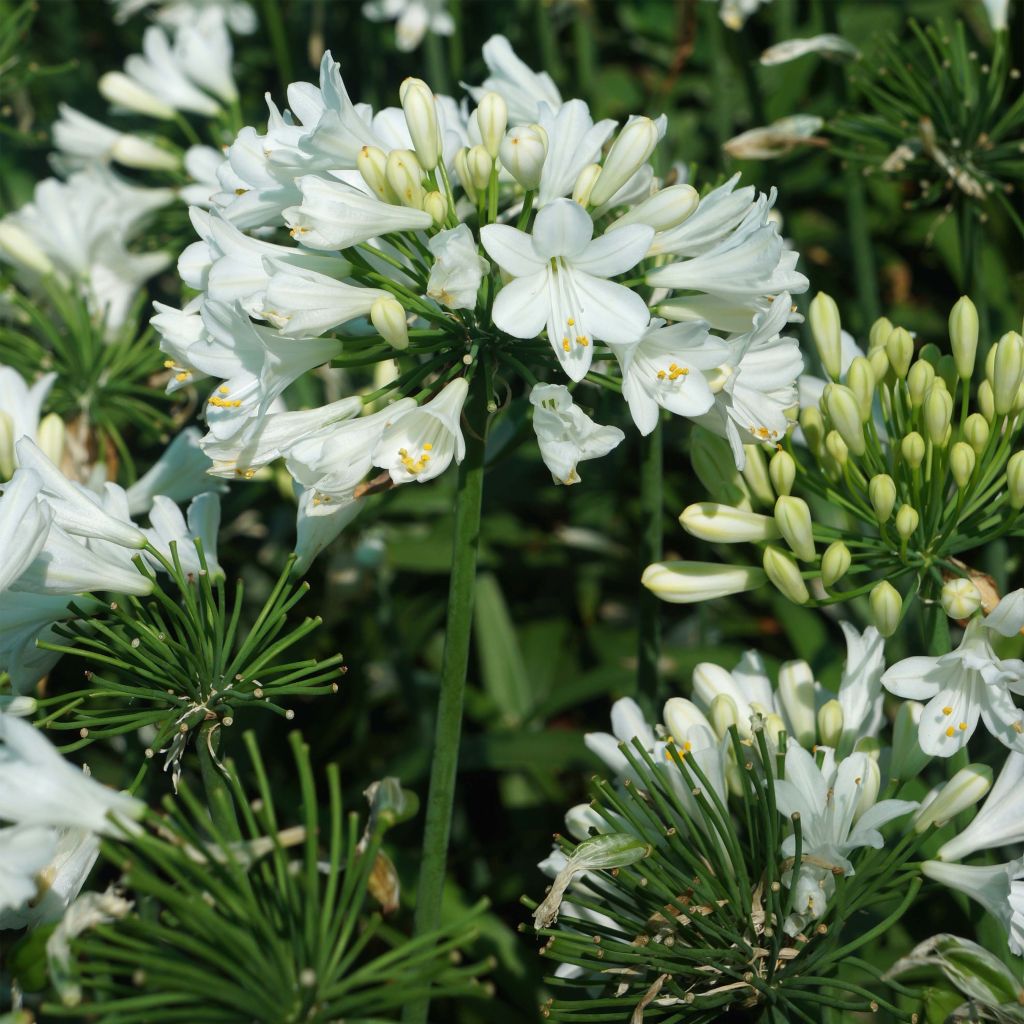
[645,295,1024,630]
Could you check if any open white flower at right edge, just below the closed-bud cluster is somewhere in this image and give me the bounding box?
[882,590,1024,758]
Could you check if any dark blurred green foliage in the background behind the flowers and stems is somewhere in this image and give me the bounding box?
[0,0,1024,1024]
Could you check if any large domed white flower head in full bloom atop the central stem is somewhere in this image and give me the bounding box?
[154,36,807,561]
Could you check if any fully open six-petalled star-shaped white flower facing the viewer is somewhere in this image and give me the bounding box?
[480,200,654,381]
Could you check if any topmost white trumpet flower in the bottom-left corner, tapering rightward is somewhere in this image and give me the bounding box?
[0,714,145,836]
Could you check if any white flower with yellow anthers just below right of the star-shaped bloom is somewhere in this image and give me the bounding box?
[614,321,729,435]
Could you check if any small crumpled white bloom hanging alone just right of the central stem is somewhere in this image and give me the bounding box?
[529,384,626,483]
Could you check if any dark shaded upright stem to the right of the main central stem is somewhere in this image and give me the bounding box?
[637,423,664,713]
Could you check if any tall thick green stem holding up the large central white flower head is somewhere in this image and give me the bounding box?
[403,378,487,1024]
